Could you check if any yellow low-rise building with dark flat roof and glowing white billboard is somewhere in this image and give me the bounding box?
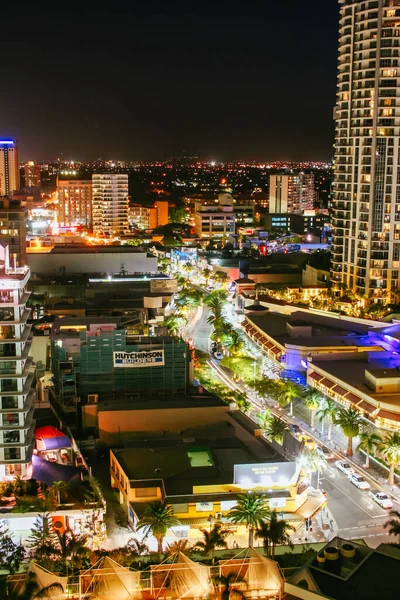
[110,407,307,539]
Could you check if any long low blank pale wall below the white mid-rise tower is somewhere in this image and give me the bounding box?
[27,250,157,275]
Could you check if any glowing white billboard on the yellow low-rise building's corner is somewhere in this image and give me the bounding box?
[233,462,300,489]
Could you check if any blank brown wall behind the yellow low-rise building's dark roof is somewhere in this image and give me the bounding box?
[97,406,229,443]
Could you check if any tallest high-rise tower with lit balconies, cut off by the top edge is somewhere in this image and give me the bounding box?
[332,0,400,298]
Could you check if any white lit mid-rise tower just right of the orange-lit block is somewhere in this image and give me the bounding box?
[92,173,129,237]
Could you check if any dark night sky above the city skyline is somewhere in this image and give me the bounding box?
[0,0,338,161]
